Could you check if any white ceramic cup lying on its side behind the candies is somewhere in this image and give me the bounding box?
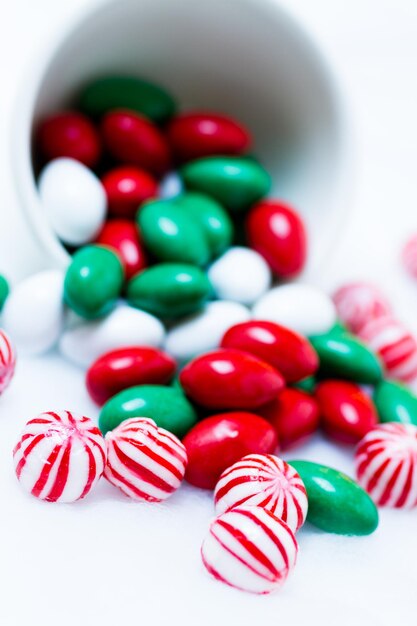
[13,0,348,277]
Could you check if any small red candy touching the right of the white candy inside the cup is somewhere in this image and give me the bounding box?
[101,165,158,220]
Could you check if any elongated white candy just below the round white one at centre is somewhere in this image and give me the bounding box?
[164,300,250,361]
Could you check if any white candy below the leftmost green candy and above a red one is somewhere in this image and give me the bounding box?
[59,304,165,367]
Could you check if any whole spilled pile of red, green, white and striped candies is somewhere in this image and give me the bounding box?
[0,77,417,593]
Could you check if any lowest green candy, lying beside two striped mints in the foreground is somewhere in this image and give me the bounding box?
[289,461,378,535]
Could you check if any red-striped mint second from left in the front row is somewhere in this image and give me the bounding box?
[104,417,187,502]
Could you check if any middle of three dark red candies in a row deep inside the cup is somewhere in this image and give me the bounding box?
[101,109,170,176]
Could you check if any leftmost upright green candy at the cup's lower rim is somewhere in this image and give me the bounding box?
[64,246,124,318]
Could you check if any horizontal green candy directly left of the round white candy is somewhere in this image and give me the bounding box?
[127,263,212,317]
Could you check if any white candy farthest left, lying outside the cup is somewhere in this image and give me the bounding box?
[2,270,64,354]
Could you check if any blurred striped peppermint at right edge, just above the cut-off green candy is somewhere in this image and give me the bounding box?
[358,315,417,382]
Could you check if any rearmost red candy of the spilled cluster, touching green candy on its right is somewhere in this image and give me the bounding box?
[220,320,319,383]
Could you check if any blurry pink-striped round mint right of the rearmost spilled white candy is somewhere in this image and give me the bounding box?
[333,283,391,333]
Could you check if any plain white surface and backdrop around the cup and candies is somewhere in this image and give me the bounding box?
[0,0,417,626]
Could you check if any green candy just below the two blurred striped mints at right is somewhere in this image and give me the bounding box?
[310,331,382,384]
